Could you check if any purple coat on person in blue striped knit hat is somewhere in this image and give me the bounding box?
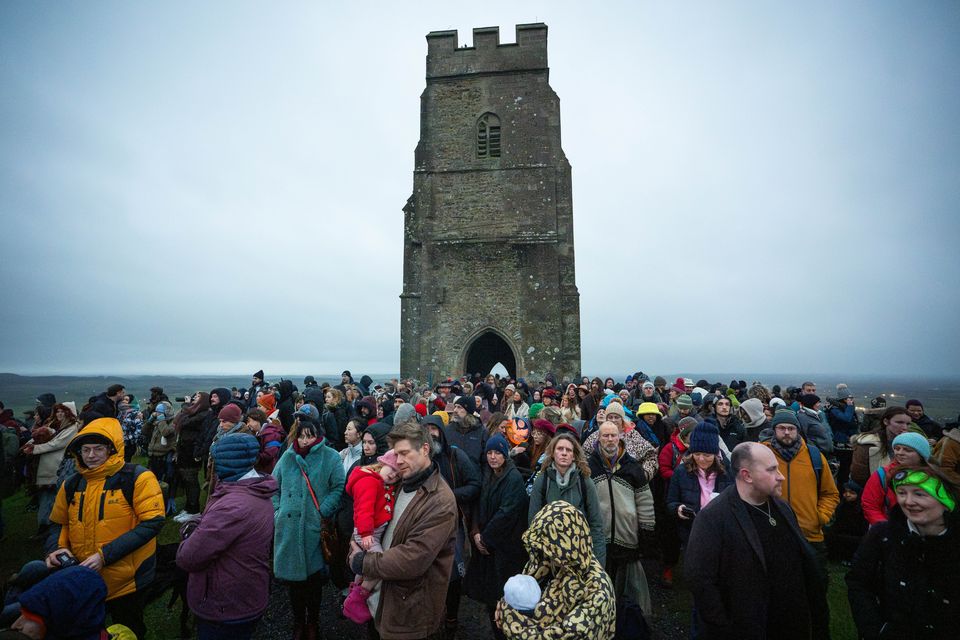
[177,476,277,622]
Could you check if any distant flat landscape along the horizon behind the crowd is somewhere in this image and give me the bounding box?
[0,372,960,422]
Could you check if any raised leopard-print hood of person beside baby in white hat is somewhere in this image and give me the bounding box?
[523,500,593,582]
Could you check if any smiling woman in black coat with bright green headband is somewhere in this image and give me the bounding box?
[846,465,960,639]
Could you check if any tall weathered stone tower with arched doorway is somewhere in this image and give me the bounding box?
[400,24,580,382]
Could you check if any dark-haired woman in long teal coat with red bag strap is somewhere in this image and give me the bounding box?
[273,413,344,638]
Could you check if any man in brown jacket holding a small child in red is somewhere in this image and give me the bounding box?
[350,421,457,640]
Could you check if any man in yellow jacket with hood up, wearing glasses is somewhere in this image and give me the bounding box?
[46,418,164,638]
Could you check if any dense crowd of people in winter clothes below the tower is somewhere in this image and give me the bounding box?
[0,371,960,640]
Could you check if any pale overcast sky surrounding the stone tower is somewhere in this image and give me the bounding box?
[0,0,960,377]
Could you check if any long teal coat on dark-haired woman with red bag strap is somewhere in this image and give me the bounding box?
[273,442,344,582]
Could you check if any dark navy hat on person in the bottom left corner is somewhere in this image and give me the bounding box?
[19,567,107,638]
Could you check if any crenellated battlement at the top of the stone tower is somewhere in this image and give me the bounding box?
[427,22,547,79]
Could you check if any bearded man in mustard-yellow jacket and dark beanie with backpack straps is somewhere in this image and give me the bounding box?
[764,409,840,557]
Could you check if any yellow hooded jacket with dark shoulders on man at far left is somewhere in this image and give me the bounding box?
[50,418,165,600]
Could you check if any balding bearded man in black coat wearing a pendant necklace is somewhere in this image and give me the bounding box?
[684,442,829,640]
